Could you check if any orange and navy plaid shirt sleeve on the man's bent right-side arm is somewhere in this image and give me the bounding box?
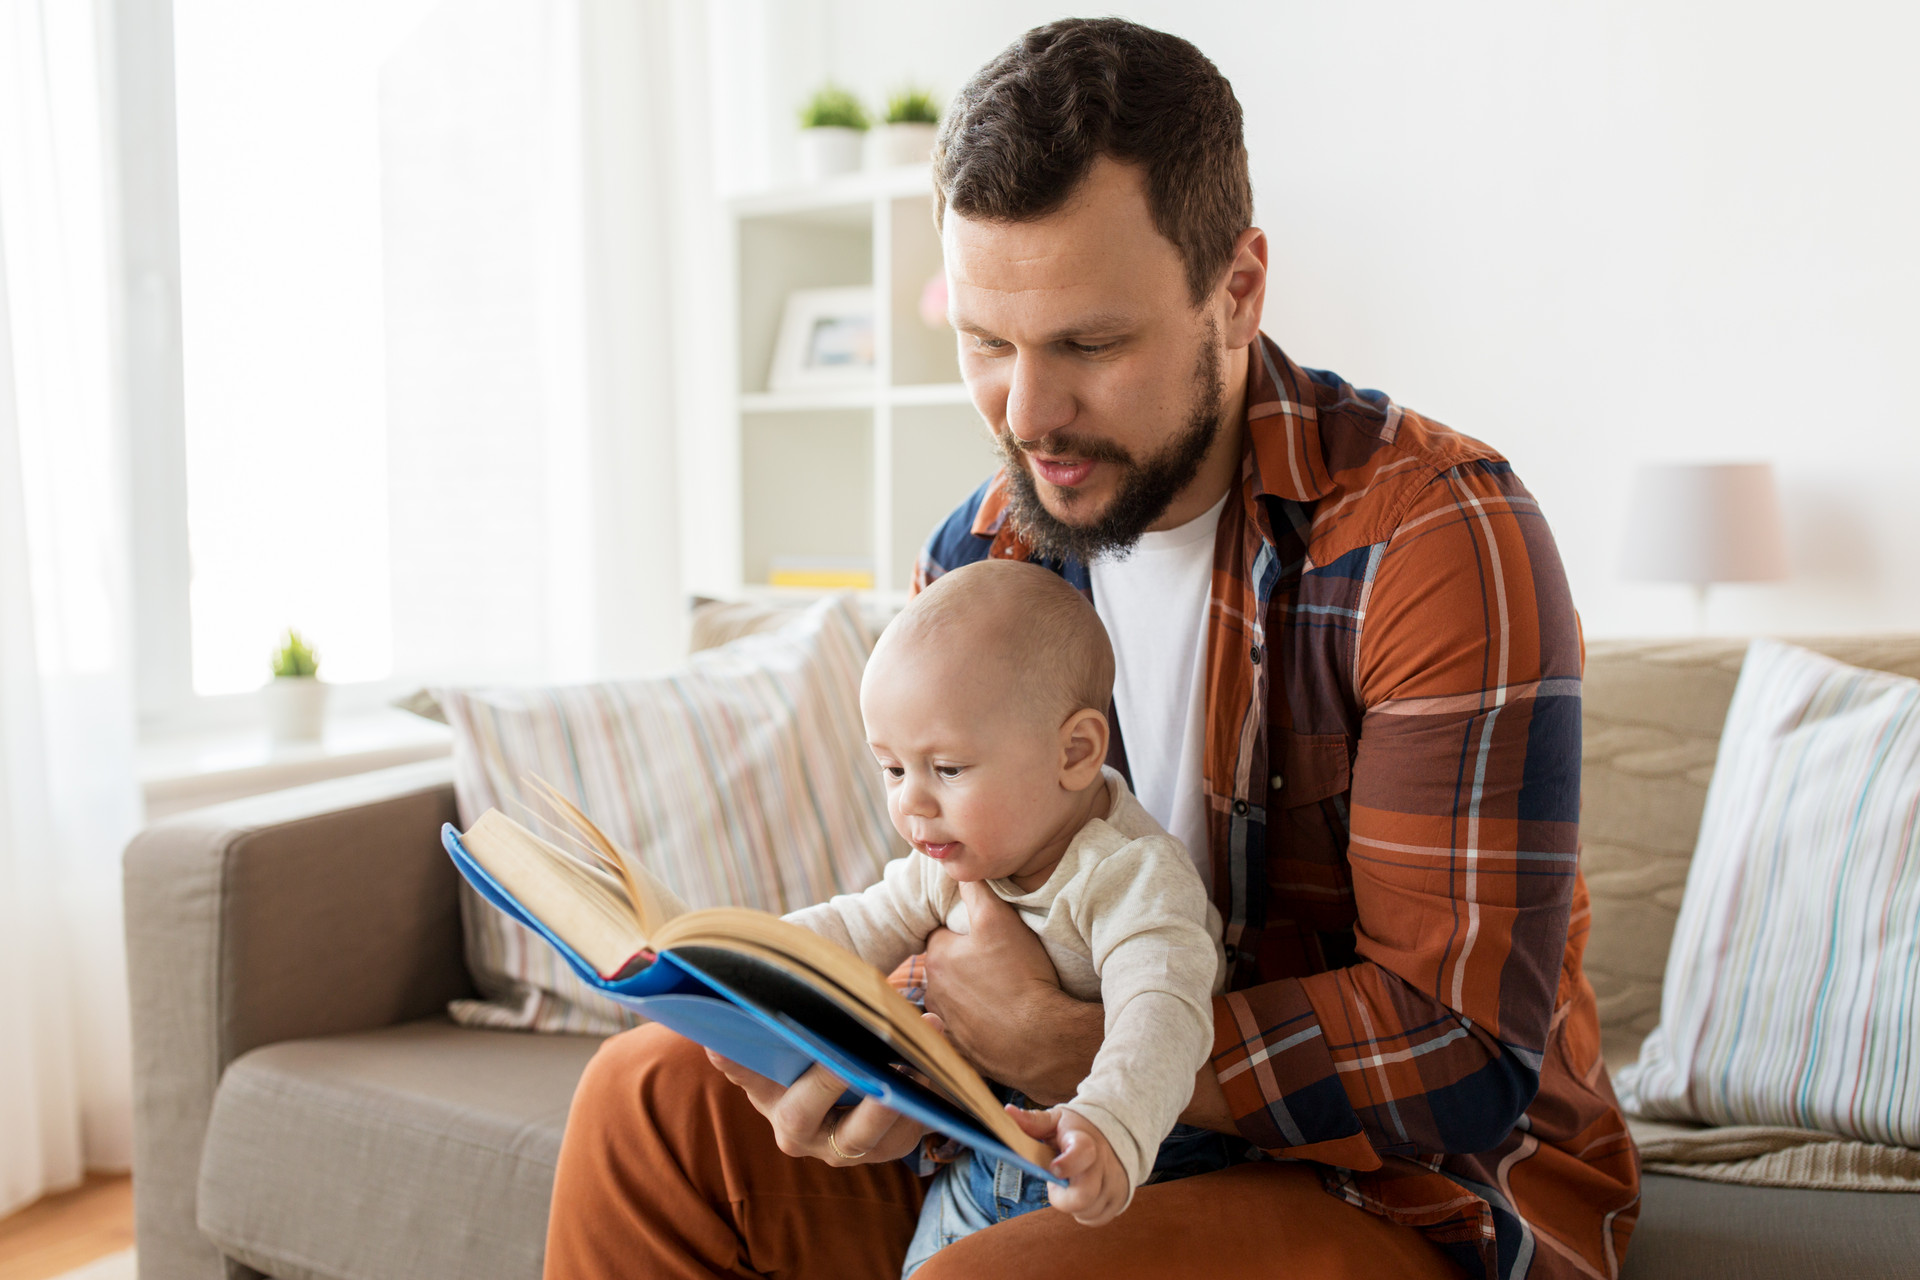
[1212,462,1580,1169]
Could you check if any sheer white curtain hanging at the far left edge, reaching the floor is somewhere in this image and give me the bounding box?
[0,0,140,1213]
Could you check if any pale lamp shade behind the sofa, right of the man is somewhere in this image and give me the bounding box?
[1620,462,1788,585]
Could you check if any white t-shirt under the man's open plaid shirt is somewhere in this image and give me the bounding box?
[1089,495,1227,892]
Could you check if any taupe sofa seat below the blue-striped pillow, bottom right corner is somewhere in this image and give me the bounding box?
[1620,1174,1920,1280]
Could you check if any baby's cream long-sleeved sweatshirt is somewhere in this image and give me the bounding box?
[787,770,1227,1197]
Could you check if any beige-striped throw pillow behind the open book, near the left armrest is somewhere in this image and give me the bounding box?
[432,599,906,1034]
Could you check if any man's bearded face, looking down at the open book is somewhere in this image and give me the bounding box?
[943,159,1225,560]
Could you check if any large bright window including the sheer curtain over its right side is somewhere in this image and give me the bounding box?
[133,0,718,739]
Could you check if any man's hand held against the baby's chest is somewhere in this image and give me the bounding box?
[927,881,1106,1103]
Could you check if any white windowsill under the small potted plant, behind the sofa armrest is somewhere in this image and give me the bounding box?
[138,708,453,821]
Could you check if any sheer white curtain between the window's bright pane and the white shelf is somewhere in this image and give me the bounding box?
[380,0,724,681]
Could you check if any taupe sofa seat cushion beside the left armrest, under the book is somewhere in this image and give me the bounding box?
[198,1021,601,1280]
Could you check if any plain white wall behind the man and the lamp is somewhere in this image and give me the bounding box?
[744,0,1920,635]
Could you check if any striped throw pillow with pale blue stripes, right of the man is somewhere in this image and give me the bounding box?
[1619,641,1920,1146]
